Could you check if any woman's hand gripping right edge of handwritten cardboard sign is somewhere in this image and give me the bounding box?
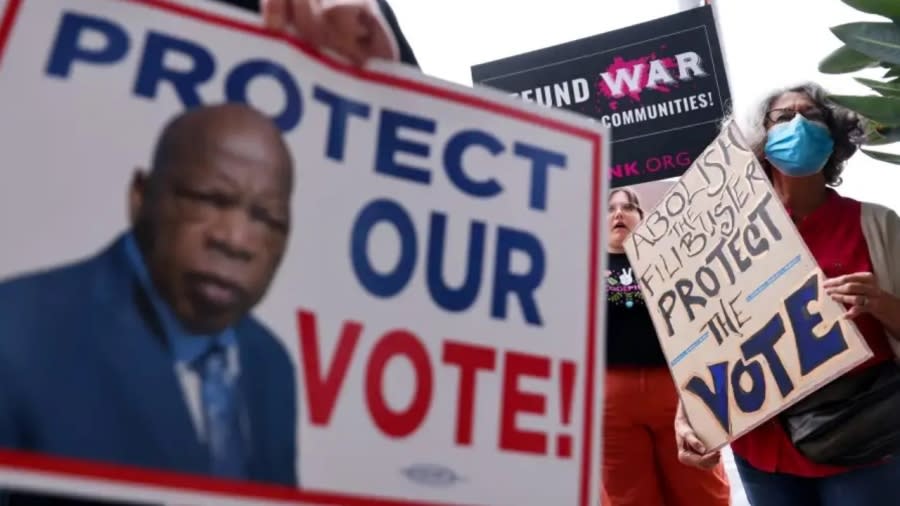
[822,272,900,336]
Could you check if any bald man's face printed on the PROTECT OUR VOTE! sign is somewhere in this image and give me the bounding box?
[138,122,291,332]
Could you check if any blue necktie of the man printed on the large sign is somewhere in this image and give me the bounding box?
[194,344,246,479]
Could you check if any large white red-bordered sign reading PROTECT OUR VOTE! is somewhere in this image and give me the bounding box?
[0,0,608,506]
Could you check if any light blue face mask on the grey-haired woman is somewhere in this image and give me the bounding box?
[766,114,834,177]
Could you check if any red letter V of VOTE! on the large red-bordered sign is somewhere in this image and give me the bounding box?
[297,310,362,425]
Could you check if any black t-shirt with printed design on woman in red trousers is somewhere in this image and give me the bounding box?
[606,253,666,367]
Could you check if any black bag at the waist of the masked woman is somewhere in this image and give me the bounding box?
[779,361,900,466]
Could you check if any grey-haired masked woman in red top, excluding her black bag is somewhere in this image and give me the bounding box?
[675,83,900,506]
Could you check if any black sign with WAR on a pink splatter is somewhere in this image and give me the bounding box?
[472,6,731,187]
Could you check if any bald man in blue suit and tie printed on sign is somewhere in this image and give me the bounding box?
[0,104,297,503]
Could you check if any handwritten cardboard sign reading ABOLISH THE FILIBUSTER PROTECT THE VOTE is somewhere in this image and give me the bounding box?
[625,122,872,448]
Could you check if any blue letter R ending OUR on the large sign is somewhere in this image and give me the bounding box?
[491,227,544,325]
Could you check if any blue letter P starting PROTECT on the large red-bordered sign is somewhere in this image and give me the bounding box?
[47,12,129,77]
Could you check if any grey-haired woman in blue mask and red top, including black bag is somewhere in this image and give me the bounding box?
[675,84,900,506]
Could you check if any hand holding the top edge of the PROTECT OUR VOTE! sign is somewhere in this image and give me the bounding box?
[262,0,400,65]
